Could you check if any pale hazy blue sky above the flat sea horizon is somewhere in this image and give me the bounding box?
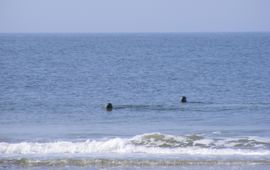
[0,0,270,32]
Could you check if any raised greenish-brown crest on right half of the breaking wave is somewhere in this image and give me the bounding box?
[131,133,270,149]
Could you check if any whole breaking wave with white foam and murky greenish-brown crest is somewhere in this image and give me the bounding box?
[0,133,270,157]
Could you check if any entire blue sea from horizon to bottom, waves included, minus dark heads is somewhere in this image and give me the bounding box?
[0,33,270,170]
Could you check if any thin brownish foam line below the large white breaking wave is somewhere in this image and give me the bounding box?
[0,159,270,167]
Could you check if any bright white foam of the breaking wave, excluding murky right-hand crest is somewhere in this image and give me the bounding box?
[0,133,270,156]
